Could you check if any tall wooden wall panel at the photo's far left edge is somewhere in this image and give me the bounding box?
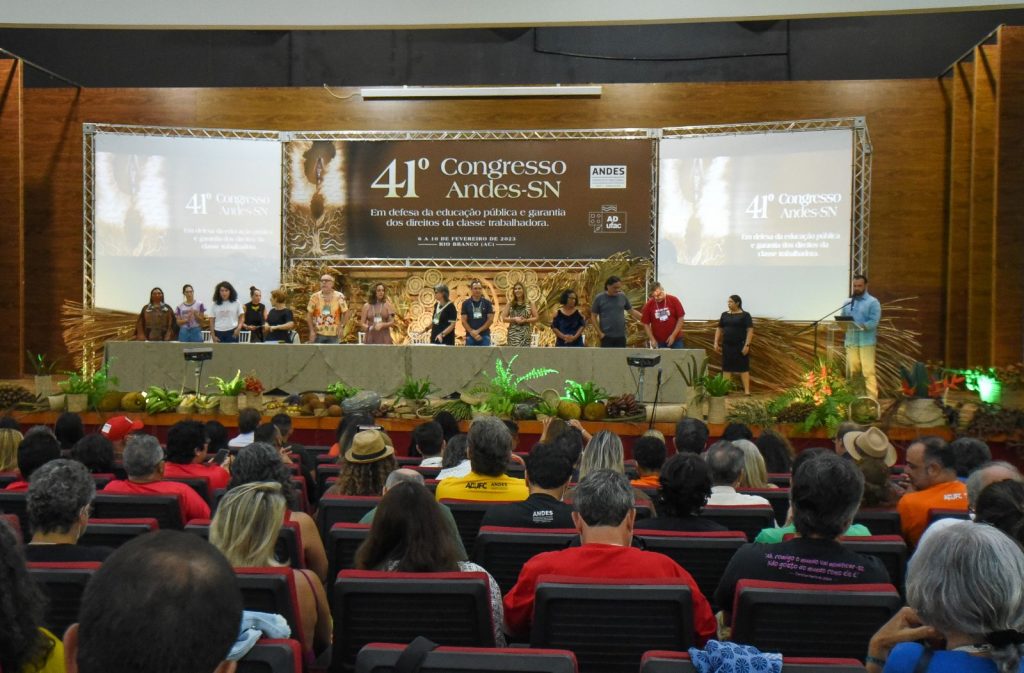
[0,58,25,378]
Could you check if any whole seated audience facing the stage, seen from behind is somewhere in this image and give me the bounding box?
[0,414,1024,673]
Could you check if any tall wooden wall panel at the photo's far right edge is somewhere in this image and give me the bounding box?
[992,26,1024,365]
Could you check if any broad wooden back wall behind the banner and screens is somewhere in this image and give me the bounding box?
[26,80,949,372]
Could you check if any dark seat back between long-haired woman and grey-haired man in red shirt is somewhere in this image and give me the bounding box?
[472,525,580,594]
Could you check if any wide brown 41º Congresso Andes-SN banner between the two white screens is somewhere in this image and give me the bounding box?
[285,138,653,259]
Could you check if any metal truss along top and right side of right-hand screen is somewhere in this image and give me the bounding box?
[654,117,871,275]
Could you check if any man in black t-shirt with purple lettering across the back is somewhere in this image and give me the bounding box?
[715,454,889,623]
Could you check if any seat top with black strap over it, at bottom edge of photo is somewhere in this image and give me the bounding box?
[355,642,579,673]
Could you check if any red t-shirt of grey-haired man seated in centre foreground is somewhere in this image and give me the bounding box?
[504,544,717,647]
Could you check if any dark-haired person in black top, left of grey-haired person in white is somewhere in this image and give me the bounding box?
[636,453,726,534]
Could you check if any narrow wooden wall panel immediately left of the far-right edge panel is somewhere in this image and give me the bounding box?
[967,45,999,366]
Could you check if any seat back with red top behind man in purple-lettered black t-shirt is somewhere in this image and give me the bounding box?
[732,580,903,659]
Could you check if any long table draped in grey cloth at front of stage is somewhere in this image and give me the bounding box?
[105,341,705,404]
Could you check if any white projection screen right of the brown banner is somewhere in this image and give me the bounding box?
[657,129,853,321]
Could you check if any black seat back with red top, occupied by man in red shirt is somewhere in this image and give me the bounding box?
[529,575,694,673]
